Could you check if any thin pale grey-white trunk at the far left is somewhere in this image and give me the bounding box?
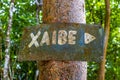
[3,0,14,80]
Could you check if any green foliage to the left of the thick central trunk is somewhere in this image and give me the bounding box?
[0,0,36,80]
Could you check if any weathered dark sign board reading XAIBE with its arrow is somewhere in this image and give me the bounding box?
[18,23,104,61]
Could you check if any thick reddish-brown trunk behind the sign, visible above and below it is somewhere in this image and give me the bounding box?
[38,0,87,80]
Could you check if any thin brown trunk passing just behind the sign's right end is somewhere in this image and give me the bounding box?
[98,0,110,80]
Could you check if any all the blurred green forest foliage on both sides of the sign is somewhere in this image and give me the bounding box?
[0,0,120,80]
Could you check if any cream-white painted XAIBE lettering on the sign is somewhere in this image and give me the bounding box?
[28,30,77,48]
